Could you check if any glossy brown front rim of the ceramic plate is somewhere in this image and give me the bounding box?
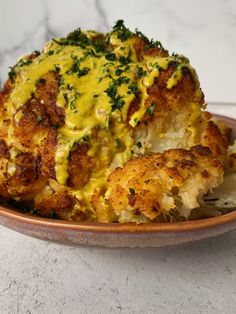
[0,206,236,233]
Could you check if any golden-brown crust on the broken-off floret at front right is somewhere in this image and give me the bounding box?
[107,145,223,220]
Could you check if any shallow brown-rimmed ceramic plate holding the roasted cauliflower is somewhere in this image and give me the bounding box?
[0,116,236,247]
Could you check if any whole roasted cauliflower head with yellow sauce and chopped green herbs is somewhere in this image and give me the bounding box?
[0,20,228,223]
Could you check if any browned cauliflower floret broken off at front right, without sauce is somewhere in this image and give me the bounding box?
[106,145,224,222]
